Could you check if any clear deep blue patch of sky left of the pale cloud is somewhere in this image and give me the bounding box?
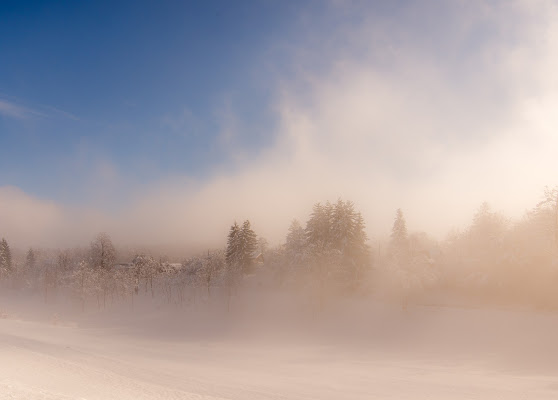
[0,1,310,202]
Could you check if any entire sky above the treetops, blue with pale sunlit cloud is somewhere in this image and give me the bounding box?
[0,0,558,245]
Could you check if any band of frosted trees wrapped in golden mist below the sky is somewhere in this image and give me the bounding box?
[0,187,558,310]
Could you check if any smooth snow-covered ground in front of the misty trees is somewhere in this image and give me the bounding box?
[0,292,558,400]
